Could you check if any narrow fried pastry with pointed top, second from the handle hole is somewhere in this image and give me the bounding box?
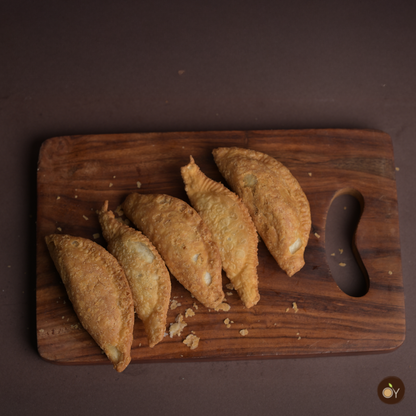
[181,156,260,308]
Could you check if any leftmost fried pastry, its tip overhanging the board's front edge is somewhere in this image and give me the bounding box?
[45,234,134,372]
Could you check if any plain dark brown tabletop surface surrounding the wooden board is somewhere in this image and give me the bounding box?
[0,0,416,415]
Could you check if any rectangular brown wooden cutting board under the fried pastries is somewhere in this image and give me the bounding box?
[36,130,405,364]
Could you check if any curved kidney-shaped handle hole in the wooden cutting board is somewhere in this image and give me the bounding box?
[325,188,369,297]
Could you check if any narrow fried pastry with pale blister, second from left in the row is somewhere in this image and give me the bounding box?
[98,201,171,347]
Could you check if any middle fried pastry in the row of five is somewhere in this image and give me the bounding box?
[123,193,224,308]
